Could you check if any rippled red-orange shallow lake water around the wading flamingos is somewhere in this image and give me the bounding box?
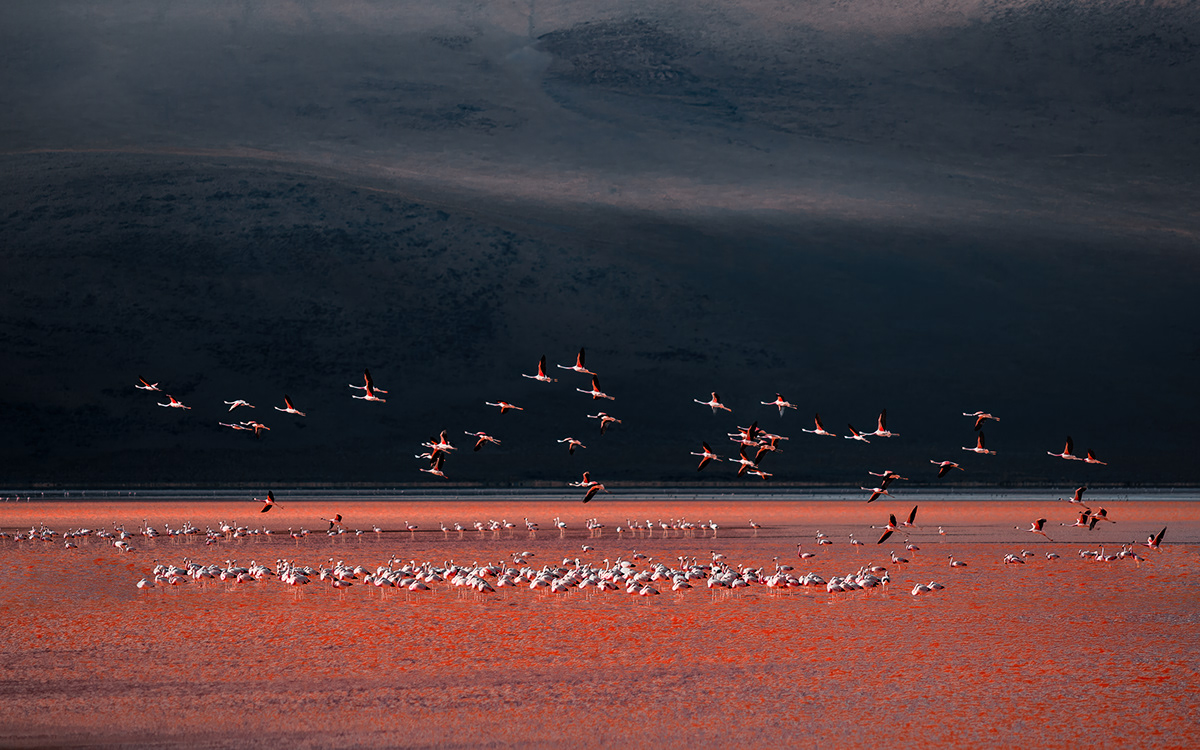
[0,493,1200,748]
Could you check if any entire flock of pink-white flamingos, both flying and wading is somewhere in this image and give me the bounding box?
[11,349,1166,595]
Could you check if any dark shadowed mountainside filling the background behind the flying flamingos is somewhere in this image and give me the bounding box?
[0,2,1200,486]
